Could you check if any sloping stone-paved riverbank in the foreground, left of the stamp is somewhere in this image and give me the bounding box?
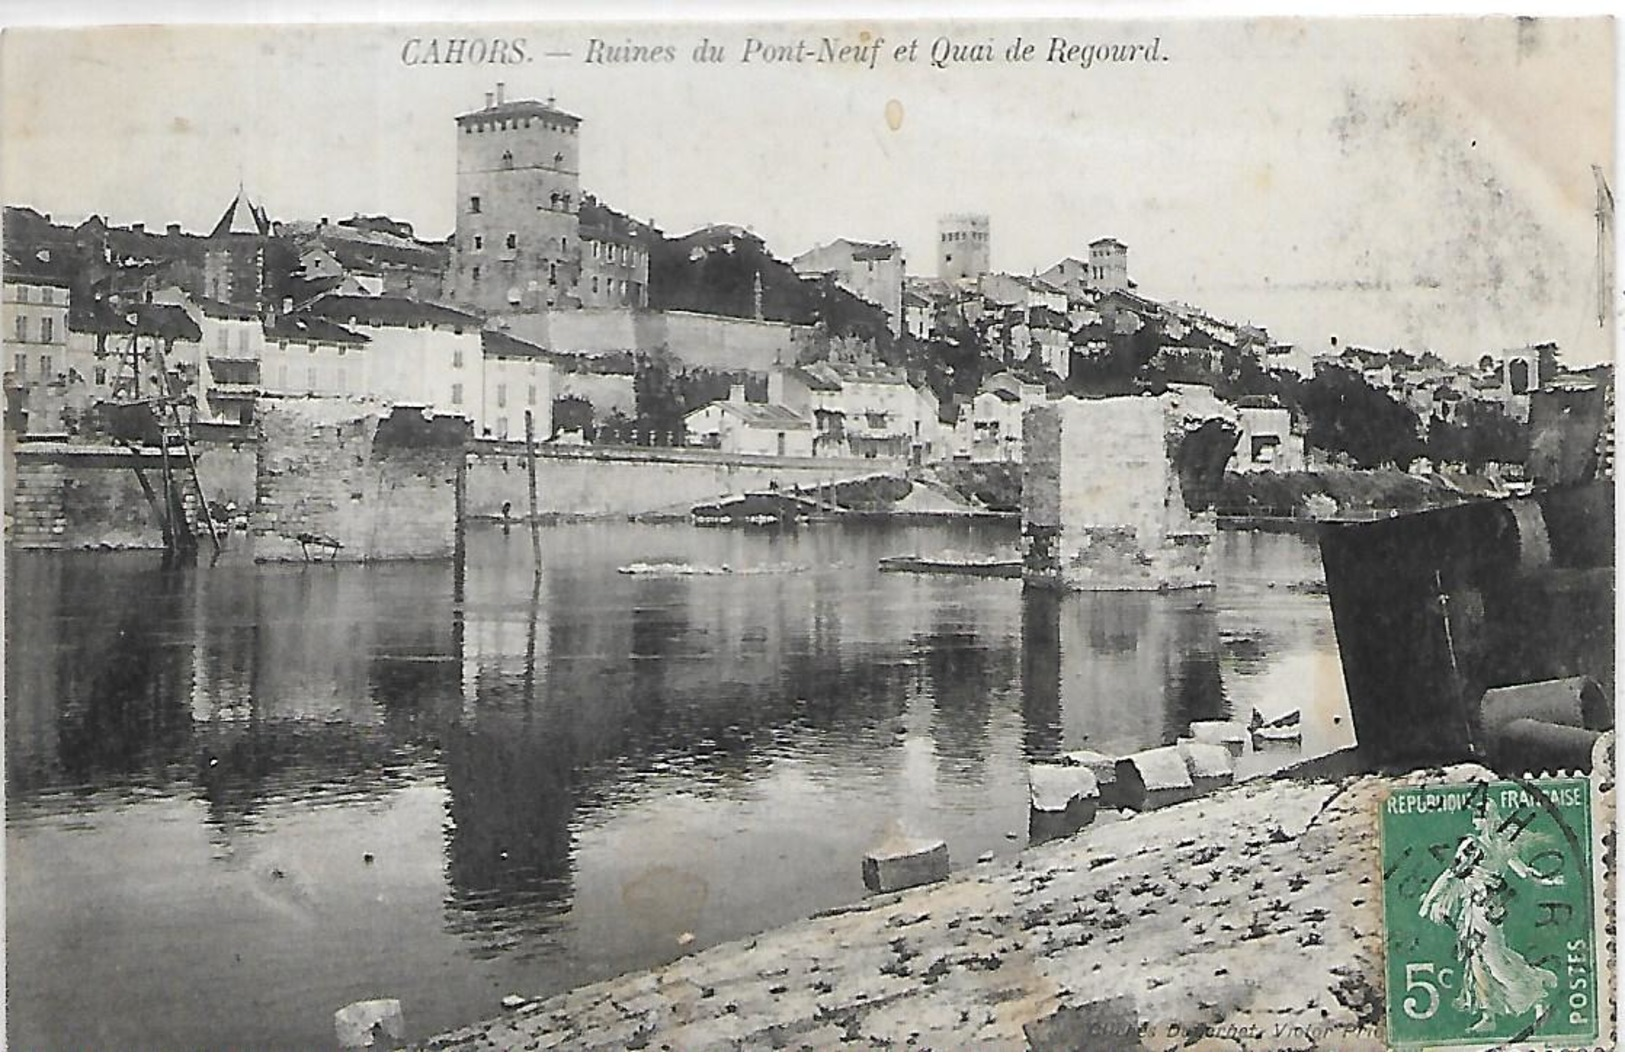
[426,767,1484,1050]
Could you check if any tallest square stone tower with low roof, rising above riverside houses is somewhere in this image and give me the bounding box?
[447,83,582,312]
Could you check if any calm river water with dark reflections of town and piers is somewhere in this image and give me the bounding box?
[5,523,1352,1050]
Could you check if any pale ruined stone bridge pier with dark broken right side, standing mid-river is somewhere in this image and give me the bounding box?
[1022,385,1240,590]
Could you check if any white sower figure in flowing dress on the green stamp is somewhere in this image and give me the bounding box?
[1420,799,1563,1032]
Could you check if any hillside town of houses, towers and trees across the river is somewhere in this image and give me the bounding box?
[0,84,1612,497]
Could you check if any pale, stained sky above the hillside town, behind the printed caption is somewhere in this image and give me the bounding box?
[0,16,1617,364]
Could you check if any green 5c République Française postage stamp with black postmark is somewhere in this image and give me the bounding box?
[1381,777,1609,1048]
